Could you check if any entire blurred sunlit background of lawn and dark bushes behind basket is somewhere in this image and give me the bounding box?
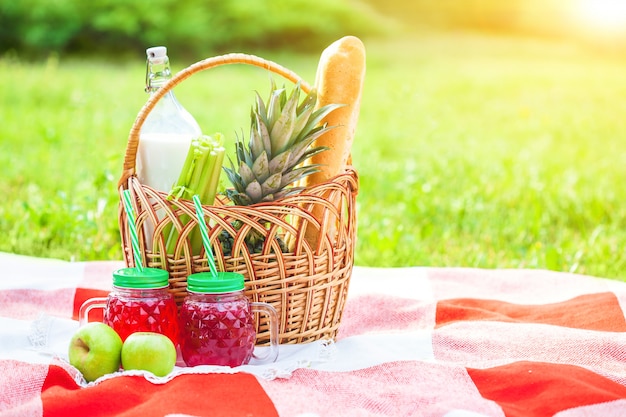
[0,0,626,279]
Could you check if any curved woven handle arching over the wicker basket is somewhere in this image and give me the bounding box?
[118,53,311,188]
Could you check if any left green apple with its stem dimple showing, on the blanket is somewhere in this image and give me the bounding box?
[68,322,122,382]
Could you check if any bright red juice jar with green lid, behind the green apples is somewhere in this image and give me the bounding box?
[103,268,178,345]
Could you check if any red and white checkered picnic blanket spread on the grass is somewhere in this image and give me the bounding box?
[0,249,626,417]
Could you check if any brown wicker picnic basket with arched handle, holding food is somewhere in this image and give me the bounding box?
[118,54,358,344]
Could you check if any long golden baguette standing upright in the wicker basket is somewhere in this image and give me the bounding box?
[304,36,365,250]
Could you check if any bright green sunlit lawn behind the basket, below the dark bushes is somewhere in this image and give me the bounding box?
[0,34,626,279]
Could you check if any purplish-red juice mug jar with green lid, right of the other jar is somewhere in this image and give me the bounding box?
[179,272,278,367]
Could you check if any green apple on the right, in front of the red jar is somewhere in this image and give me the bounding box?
[122,332,176,376]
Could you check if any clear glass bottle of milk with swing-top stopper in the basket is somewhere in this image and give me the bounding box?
[136,46,202,193]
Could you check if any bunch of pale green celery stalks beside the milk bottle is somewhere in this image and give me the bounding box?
[164,133,225,255]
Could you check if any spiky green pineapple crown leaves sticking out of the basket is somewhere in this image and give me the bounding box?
[224,80,341,205]
